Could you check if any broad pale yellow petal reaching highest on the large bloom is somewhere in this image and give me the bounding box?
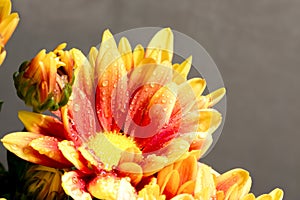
[145,28,174,63]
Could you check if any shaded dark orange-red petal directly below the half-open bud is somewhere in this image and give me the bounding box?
[18,111,65,138]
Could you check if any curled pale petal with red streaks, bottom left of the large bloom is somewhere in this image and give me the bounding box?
[61,171,92,200]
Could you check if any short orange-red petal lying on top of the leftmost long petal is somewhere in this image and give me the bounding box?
[29,136,72,167]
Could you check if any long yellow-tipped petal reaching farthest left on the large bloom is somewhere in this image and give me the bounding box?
[1,132,66,168]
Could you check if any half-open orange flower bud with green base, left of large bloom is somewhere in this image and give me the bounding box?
[14,43,79,112]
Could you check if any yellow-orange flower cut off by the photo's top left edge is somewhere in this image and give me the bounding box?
[0,0,19,65]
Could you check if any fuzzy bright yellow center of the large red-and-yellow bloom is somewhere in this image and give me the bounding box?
[87,132,138,170]
